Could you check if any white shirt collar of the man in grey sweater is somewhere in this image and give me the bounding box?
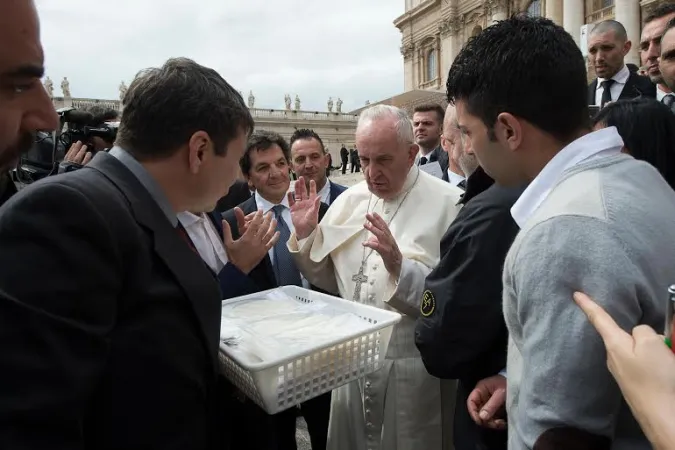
[511,127,623,228]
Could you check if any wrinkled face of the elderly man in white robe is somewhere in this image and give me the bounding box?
[356,119,419,200]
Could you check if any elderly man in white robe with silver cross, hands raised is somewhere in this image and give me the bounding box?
[288,105,462,450]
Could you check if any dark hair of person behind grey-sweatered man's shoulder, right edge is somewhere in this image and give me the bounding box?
[593,97,675,189]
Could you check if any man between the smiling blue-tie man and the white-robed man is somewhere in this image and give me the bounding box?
[291,128,347,206]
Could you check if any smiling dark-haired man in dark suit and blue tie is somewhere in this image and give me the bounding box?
[223,130,330,450]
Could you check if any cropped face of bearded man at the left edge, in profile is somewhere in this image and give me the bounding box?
[0,0,58,205]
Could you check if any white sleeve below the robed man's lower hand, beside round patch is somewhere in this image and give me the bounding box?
[384,258,431,317]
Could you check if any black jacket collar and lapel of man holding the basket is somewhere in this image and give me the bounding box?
[87,152,221,370]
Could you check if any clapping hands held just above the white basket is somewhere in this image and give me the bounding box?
[223,207,279,274]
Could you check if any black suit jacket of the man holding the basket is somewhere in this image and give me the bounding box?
[0,152,223,450]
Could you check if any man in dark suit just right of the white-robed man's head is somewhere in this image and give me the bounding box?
[413,103,449,181]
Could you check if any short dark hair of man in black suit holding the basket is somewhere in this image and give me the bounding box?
[116,58,253,160]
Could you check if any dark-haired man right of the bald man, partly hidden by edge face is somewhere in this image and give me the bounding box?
[640,2,675,101]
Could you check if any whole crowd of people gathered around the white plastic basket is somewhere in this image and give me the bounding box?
[0,0,675,450]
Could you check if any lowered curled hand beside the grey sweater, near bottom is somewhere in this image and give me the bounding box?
[466,375,506,430]
